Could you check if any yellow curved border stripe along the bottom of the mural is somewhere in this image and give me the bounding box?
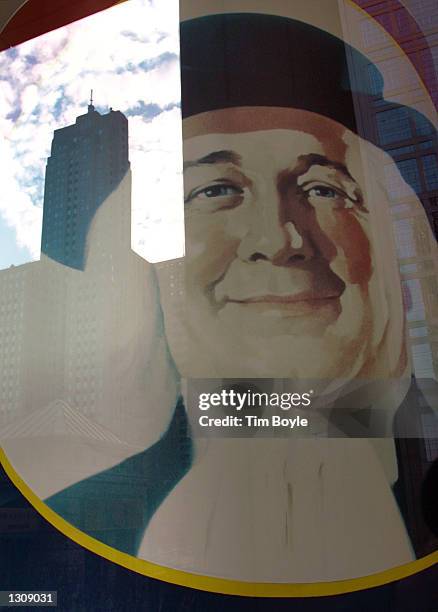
[0,448,438,597]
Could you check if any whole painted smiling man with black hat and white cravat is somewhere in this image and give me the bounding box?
[3,4,438,582]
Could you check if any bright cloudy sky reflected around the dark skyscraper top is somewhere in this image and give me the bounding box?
[0,0,184,268]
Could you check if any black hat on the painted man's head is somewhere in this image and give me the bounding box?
[180,13,436,206]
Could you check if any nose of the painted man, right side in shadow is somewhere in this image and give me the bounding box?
[237,185,314,266]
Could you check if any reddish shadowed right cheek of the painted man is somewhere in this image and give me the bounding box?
[317,210,373,285]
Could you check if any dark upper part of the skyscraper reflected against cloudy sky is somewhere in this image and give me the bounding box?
[41,98,129,270]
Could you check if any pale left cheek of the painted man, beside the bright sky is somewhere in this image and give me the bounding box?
[185,213,239,289]
